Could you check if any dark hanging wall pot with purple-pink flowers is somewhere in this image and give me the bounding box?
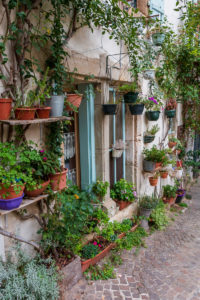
[144,97,162,121]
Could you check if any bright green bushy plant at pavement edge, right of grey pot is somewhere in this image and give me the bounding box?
[150,201,169,230]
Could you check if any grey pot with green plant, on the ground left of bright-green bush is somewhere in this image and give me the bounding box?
[139,195,159,230]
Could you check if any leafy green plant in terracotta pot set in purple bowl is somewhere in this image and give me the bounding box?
[0,143,32,210]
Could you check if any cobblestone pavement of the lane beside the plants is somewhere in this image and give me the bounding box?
[65,184,200,300]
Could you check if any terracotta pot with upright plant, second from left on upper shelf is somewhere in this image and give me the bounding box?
[14,91,36,120]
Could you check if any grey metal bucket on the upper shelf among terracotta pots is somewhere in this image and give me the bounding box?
[46,95,65,117]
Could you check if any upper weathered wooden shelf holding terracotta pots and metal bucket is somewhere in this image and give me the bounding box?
[0,116,72,126]
